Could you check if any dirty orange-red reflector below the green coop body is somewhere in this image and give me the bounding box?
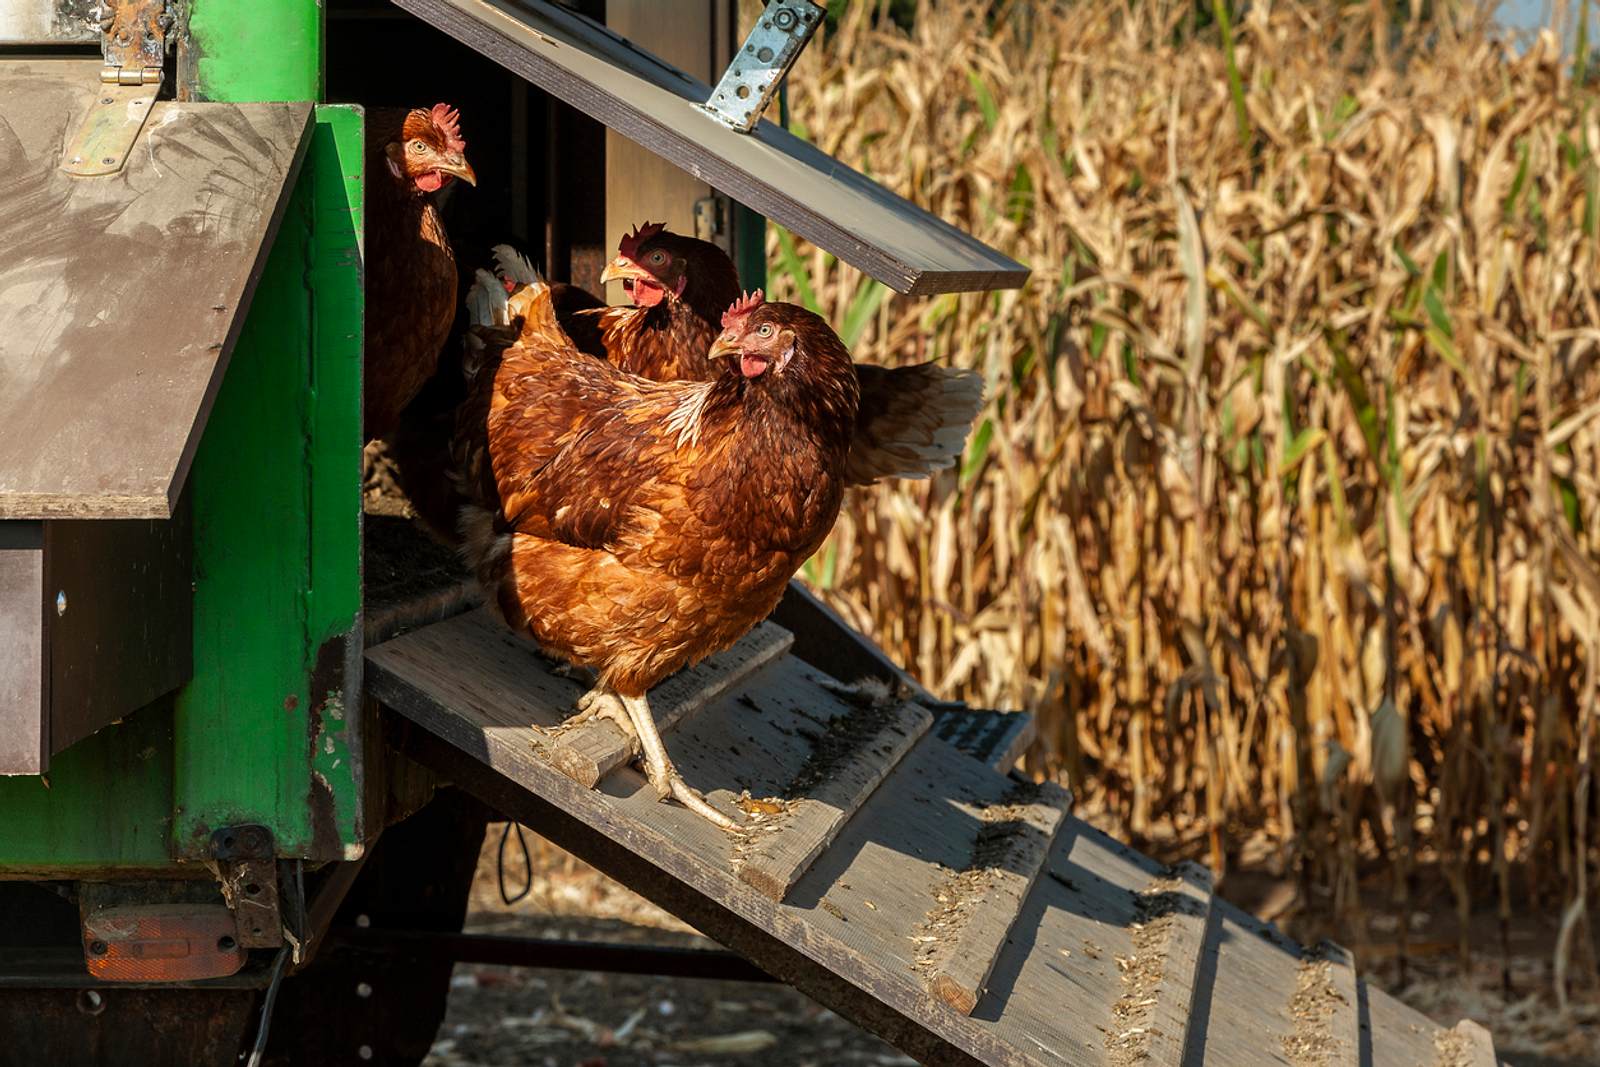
[83,904,245,982]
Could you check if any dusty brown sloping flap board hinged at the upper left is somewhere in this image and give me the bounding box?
[0,59,312,518]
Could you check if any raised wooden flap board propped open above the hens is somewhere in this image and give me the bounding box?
[395,0,1029,294]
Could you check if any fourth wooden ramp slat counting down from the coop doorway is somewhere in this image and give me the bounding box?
[1107,862,1213,1067]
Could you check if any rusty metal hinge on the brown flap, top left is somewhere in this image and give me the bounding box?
[61,0,173,178]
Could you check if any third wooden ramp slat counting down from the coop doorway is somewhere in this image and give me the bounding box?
[918,782,1072,1016]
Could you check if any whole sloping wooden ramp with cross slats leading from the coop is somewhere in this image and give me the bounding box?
[366,609,1493,1067]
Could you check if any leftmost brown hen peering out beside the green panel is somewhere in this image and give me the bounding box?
[362,104,477,442]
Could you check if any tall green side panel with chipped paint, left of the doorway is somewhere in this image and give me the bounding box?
[173,107,362,859]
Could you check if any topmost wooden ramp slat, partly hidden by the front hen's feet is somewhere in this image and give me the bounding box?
[544,622,794,787]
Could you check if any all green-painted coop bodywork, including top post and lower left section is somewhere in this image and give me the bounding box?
[0,0,366,878]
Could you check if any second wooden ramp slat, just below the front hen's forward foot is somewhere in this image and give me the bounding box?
[734,702,933,901]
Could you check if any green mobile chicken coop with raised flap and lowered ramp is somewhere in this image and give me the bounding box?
[0,0,1493,1067]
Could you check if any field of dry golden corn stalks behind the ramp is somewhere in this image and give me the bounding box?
[768,0,1600,995]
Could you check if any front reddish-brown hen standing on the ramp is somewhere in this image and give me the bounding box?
[454,261,859,829]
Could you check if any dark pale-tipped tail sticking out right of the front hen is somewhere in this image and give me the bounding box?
[845,363,984,485]
